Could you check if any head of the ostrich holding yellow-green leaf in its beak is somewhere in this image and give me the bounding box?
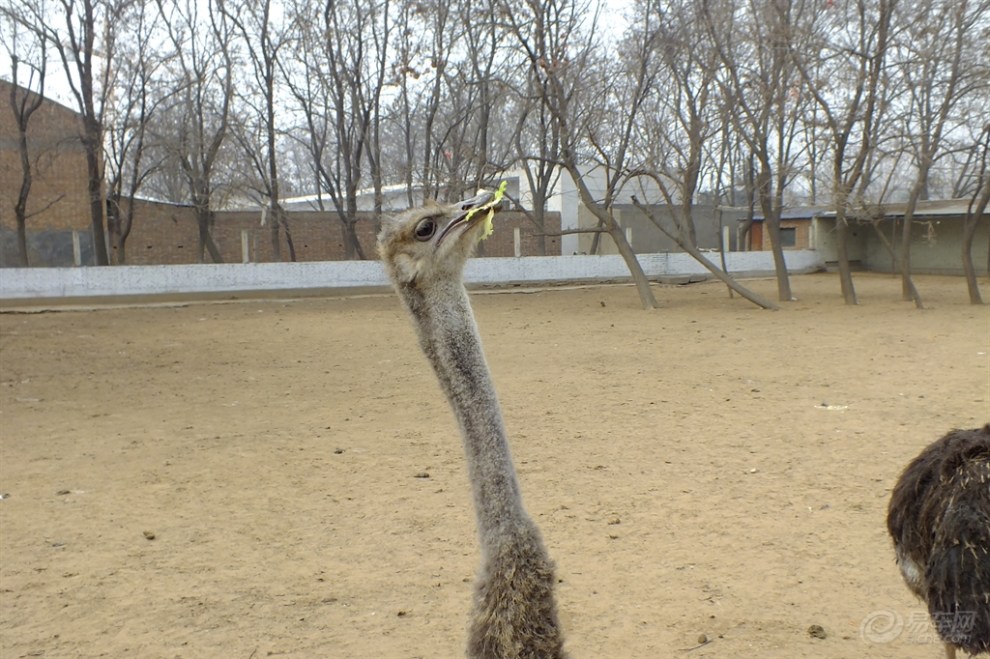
[378,191,498,290]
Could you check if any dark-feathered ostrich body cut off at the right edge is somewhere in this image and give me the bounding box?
[887,424,990,659]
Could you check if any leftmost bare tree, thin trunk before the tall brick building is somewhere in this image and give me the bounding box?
[4,17,48,267]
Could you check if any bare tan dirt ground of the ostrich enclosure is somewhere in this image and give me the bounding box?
[0,275,990,659]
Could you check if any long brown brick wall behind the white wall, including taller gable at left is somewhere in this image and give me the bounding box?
[0,80,560,266]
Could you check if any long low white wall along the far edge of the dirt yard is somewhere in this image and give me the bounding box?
[0,250,824,300]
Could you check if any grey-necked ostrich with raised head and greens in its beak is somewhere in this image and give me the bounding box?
[378,193,566,659]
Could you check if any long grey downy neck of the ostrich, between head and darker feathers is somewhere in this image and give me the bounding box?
[403,282,528,548]
